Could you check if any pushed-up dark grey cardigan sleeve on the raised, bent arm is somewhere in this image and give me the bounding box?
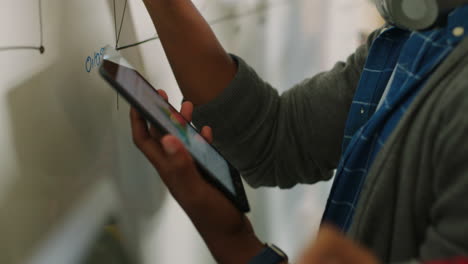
[193,31,379,188]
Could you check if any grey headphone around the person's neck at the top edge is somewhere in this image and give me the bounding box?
[374,0,468,31]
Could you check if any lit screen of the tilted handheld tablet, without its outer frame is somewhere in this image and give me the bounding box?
[103,60,236,196]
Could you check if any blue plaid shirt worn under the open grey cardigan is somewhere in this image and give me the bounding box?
[323,5,468,231]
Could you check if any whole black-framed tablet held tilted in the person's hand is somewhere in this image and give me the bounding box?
[99,47,250,212]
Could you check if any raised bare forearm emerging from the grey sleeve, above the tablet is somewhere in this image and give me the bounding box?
[144,0,237,105]
